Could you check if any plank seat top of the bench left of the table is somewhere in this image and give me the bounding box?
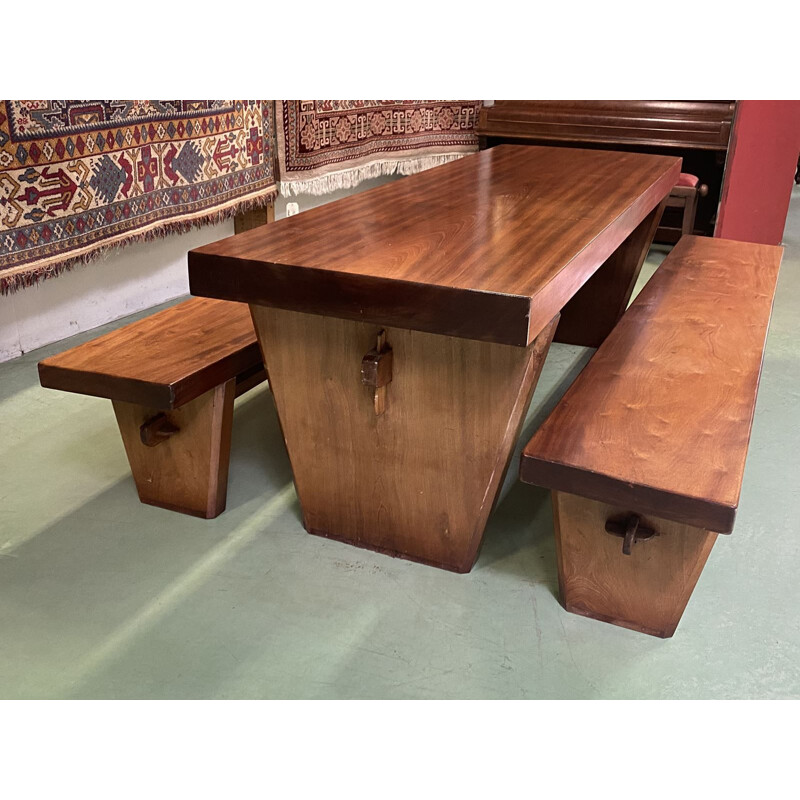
[39,298,261,409]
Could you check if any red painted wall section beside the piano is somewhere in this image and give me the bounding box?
[714,100,800,244]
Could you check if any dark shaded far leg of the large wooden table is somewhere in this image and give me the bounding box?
[553,198,667,347]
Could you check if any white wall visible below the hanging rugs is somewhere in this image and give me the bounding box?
[0,176,395,362]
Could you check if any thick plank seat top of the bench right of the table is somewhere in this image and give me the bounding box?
[520,241,782,533]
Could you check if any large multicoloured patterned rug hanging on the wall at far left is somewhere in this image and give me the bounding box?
[0,100,276,294]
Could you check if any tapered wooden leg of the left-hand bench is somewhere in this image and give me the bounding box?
[113,380,236,519]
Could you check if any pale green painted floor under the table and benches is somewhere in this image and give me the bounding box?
[0,188,800,698]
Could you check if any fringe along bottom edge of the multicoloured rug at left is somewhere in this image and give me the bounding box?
[0,188,277,295]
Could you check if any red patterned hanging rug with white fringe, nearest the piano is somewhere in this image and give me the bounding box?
[275,100,481,195]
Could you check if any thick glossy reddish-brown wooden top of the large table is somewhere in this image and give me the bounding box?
[189,145,681,346]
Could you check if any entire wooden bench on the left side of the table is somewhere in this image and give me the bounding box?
[39,298,266,519]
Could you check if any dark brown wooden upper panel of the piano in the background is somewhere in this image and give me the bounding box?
[478,100,735,150]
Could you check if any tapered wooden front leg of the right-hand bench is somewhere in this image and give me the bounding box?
[552,492,717,638]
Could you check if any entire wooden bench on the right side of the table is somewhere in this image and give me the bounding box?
[520,236,782,637]
